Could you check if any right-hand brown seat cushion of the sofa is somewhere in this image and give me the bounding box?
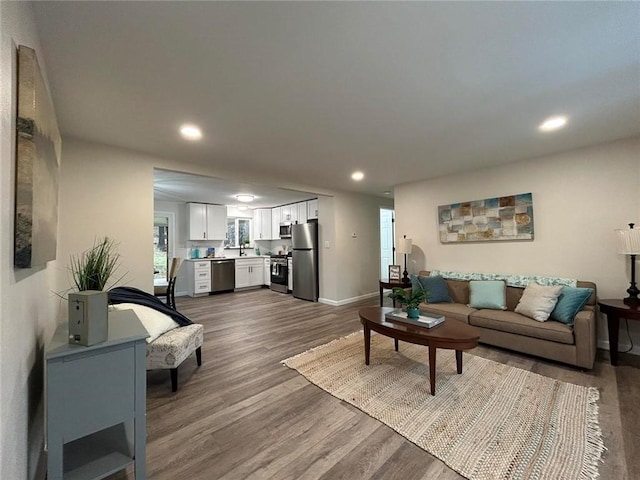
[469,309,574,345]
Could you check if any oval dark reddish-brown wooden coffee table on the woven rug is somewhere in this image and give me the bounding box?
[358,307,480,395]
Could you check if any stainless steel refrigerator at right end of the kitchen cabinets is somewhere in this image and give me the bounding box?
[291,222,318,302]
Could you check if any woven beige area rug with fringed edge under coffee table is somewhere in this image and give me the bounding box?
[282,332,605,480]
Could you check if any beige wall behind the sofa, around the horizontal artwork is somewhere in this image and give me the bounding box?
[395,138,640,346]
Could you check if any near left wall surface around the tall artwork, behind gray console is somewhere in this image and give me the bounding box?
[0,2,59,479]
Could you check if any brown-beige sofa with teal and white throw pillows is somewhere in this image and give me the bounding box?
[419,271,596,369]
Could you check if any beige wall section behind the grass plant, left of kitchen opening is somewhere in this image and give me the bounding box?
[58,141,154,292]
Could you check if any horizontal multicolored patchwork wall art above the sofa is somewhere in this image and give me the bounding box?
[438,193,533,243]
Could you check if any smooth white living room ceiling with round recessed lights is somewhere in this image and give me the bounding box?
[34,2,640,199]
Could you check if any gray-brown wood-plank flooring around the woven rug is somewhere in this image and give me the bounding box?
[112,289,640,480]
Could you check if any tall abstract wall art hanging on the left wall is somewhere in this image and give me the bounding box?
[13,45,61,268]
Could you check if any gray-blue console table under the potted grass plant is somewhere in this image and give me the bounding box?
[45,310,149,480]
